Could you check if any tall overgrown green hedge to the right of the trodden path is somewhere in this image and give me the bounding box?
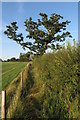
[33,41,80,120]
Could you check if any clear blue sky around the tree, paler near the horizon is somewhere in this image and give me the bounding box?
[0,2,78,59]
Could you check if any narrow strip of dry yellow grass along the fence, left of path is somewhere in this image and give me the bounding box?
[6,63,27,118]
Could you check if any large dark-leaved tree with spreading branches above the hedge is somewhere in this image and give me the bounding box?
[4,13,72,55]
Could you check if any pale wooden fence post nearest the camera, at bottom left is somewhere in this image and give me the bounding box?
[2,90,6,120]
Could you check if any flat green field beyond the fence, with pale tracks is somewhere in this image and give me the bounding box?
[2,62,27,89]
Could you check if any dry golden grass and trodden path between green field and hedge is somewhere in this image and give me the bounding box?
[7,64,44,119]
